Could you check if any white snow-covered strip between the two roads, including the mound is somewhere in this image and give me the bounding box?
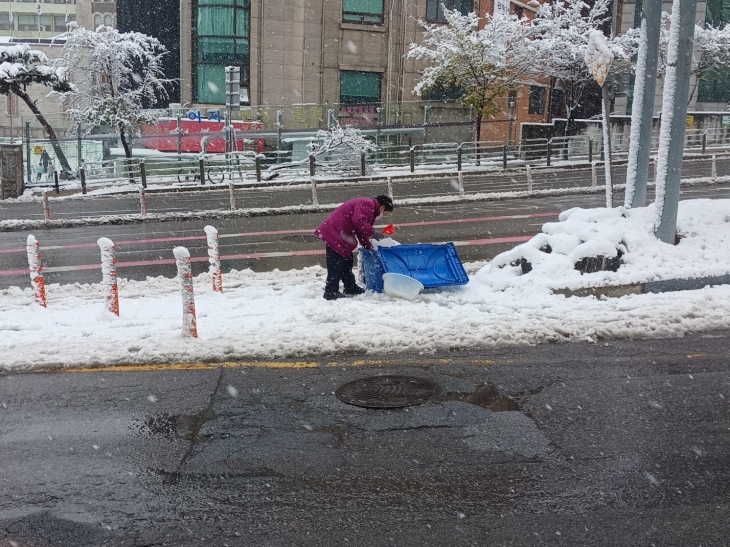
[0,200,730,371]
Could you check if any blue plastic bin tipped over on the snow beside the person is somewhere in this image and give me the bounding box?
[360,243,469,292]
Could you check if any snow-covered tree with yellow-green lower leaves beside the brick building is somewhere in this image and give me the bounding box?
[407,8,540,141]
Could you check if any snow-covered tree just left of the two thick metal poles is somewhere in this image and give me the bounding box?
[533,0,638,133]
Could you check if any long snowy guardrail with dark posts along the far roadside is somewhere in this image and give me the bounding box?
[18,124,730,193]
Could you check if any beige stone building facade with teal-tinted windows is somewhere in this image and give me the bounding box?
[180,0,478,110]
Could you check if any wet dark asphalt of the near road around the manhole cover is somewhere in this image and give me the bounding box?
[0,332,730,547]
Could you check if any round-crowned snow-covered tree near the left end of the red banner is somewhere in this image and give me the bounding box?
[60,23,170,158]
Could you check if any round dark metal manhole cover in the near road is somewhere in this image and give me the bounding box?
[335,376,441,408]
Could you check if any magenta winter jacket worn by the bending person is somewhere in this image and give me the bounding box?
[314,198,380,258]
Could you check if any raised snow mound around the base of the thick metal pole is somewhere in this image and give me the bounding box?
[475,199,730,291]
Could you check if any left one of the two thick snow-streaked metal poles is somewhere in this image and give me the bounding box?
[624,0,666,207]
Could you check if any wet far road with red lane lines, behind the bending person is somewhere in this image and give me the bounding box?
[0,184,730,288]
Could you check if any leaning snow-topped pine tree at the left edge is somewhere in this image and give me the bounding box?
[0,44,71,178]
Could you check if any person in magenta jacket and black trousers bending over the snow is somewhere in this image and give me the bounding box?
[314,196,393,300]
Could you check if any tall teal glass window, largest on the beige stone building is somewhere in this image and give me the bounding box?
[195,0,251,104]
